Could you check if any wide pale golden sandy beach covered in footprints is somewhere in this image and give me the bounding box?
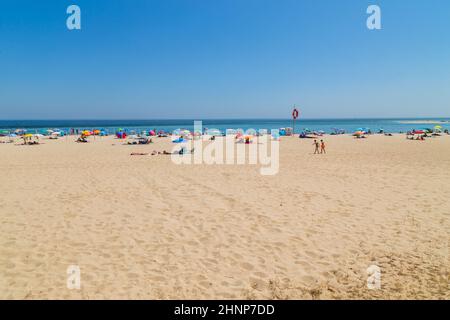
[0,135,450,299]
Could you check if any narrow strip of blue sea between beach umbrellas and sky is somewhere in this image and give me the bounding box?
[0,118,450,133]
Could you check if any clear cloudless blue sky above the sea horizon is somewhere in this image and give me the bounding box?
[0,0,450,119]
